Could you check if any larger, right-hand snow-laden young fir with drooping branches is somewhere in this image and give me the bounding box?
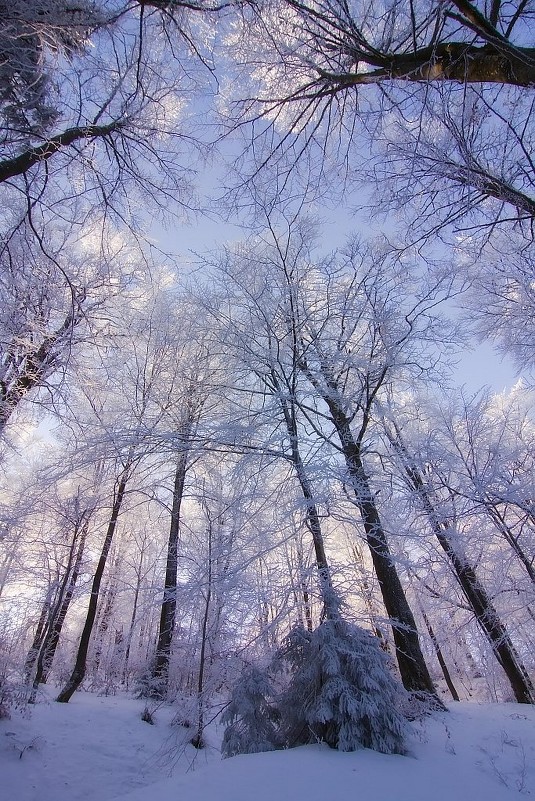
[275,618,408,754]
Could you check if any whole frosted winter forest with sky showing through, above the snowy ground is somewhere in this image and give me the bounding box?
[0,0,535,768]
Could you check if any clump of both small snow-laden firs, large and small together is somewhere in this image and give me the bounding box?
[223,619,408,756]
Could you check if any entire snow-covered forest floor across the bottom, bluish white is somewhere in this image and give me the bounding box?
[0,693,535,801]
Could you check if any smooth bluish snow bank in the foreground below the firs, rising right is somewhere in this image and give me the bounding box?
[115,704,535,801]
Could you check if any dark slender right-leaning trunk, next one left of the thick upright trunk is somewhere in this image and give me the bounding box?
[56,464,130,704]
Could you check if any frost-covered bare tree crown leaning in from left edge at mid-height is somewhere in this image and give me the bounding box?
[0,219,140,436]
